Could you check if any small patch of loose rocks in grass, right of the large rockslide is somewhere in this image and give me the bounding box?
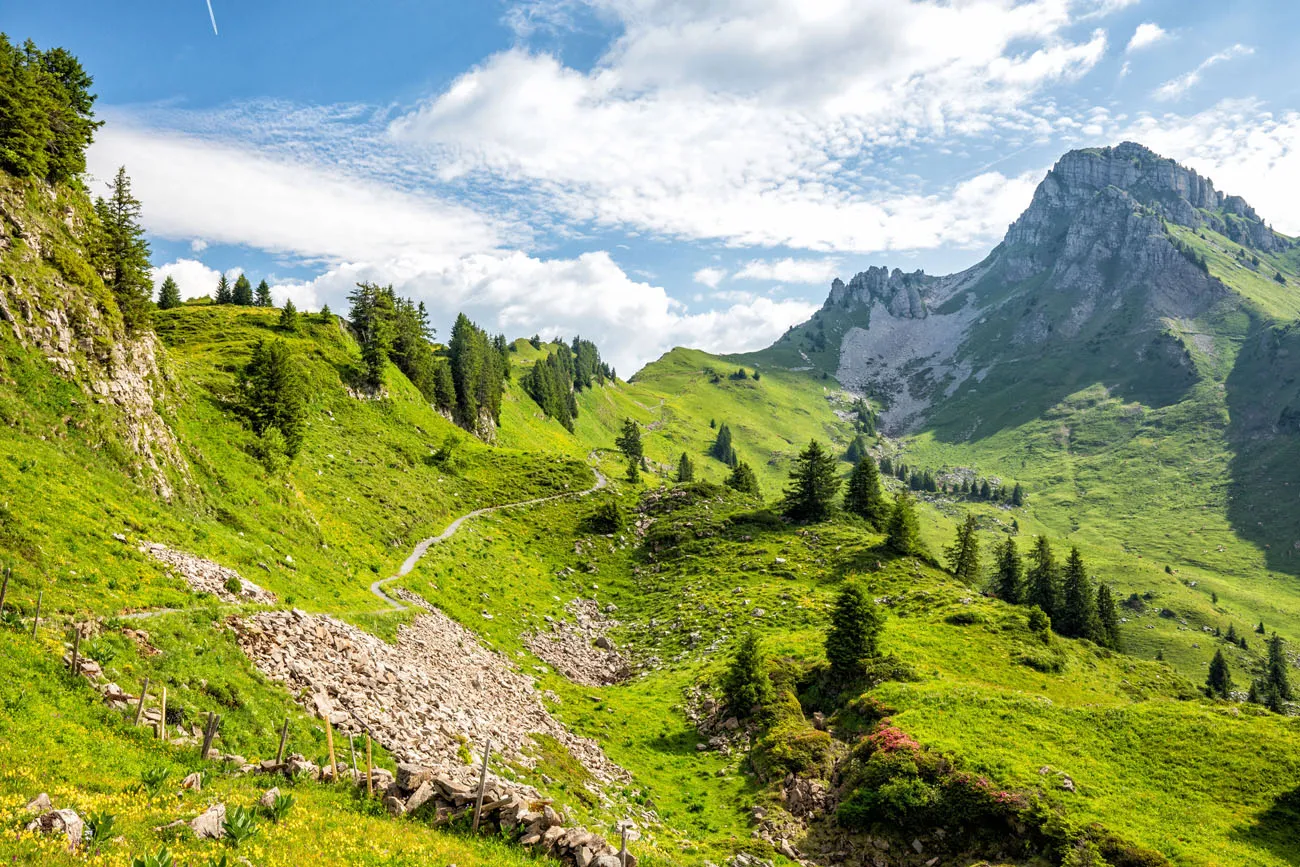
[525,599,632,686]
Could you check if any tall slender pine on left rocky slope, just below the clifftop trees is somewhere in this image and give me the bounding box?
[95,166,153,330]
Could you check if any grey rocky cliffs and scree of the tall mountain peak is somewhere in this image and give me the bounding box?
[815,142,1291,433]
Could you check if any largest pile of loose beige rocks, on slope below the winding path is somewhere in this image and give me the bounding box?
[231,610,628,783]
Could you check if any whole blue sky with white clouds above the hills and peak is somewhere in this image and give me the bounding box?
[10,0,1300,373]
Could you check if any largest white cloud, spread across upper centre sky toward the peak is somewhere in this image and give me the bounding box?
[390,0,1114,252]
